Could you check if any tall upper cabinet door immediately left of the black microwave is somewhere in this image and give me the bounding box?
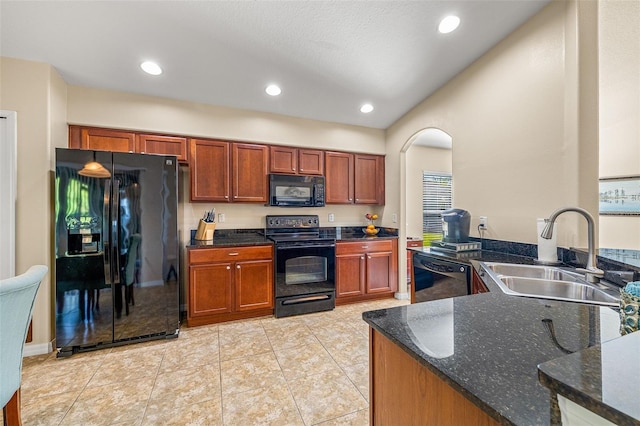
[231,143,269,203]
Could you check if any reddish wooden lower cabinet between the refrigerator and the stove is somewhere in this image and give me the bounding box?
[187,246,273,327]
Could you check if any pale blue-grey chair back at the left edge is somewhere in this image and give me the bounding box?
[0,265,48,407]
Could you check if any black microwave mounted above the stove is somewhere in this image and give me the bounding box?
[269,174,324,207]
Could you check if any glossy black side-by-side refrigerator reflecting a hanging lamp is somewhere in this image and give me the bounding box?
[55,148,180,357]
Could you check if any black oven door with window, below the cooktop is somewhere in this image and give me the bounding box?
[275,242,336,300]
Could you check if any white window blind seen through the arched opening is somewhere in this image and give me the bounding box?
[422,171,452,240]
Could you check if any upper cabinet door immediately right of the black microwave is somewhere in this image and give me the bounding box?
[324,151,353,204]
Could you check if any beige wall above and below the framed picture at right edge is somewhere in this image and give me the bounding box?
[599,0,640,250]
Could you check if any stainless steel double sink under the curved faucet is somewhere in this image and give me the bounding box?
[480,262,619,306]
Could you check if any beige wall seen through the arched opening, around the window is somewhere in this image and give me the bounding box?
[404,142,455,239]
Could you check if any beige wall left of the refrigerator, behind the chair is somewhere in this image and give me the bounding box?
[0,58,67,354]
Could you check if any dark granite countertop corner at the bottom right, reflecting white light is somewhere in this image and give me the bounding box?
[538,332,640,425]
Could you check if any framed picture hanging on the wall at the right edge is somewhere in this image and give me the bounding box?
[599,176,640,216]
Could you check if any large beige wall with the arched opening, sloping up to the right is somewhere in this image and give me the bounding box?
[387,1,597,292]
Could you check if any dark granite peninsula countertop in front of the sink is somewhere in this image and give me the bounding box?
[363,291,620,425]
